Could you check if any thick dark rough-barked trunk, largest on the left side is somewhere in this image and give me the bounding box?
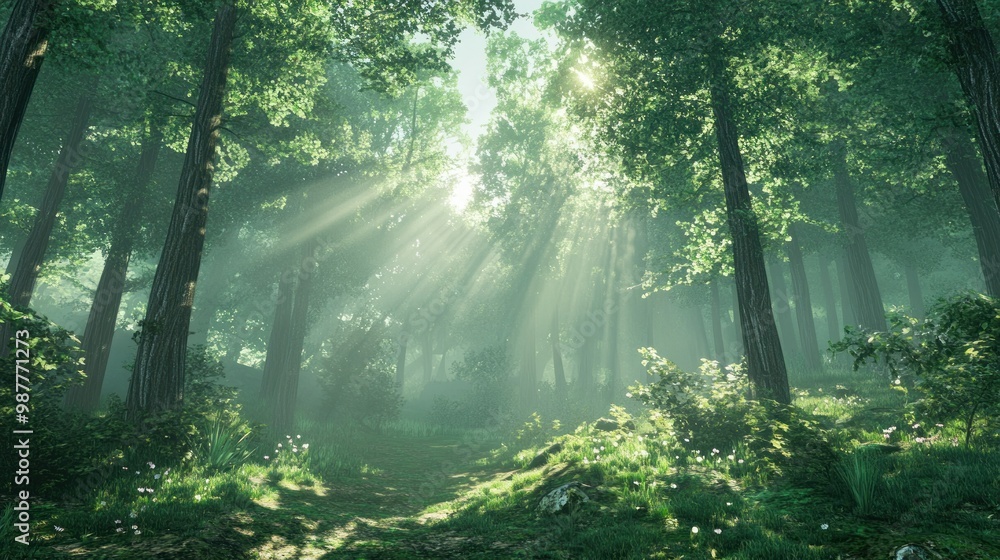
[126,2,236,419]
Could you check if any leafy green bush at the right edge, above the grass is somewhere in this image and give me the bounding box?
[831,293,1000,445]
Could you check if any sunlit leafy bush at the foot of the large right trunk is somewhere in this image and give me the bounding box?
[630,348,834,480]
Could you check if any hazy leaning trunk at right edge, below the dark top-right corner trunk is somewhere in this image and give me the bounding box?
[944,130,1000,297]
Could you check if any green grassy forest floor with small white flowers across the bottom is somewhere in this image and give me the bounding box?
[11,373,1000,560]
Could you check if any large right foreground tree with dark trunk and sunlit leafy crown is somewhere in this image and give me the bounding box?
[543,0,790,402]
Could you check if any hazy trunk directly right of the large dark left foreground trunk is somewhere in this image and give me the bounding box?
[271,237,319,432]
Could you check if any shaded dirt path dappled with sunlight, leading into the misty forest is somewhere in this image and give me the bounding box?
[226,437,508,560]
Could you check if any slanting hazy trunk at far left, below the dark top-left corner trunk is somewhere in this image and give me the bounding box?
[8,96,94,307]
